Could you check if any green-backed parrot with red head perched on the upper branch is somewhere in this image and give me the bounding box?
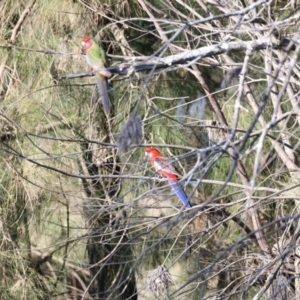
[81,37,111,112]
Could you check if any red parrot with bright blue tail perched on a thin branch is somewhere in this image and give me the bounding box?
[145,147,192,207]
